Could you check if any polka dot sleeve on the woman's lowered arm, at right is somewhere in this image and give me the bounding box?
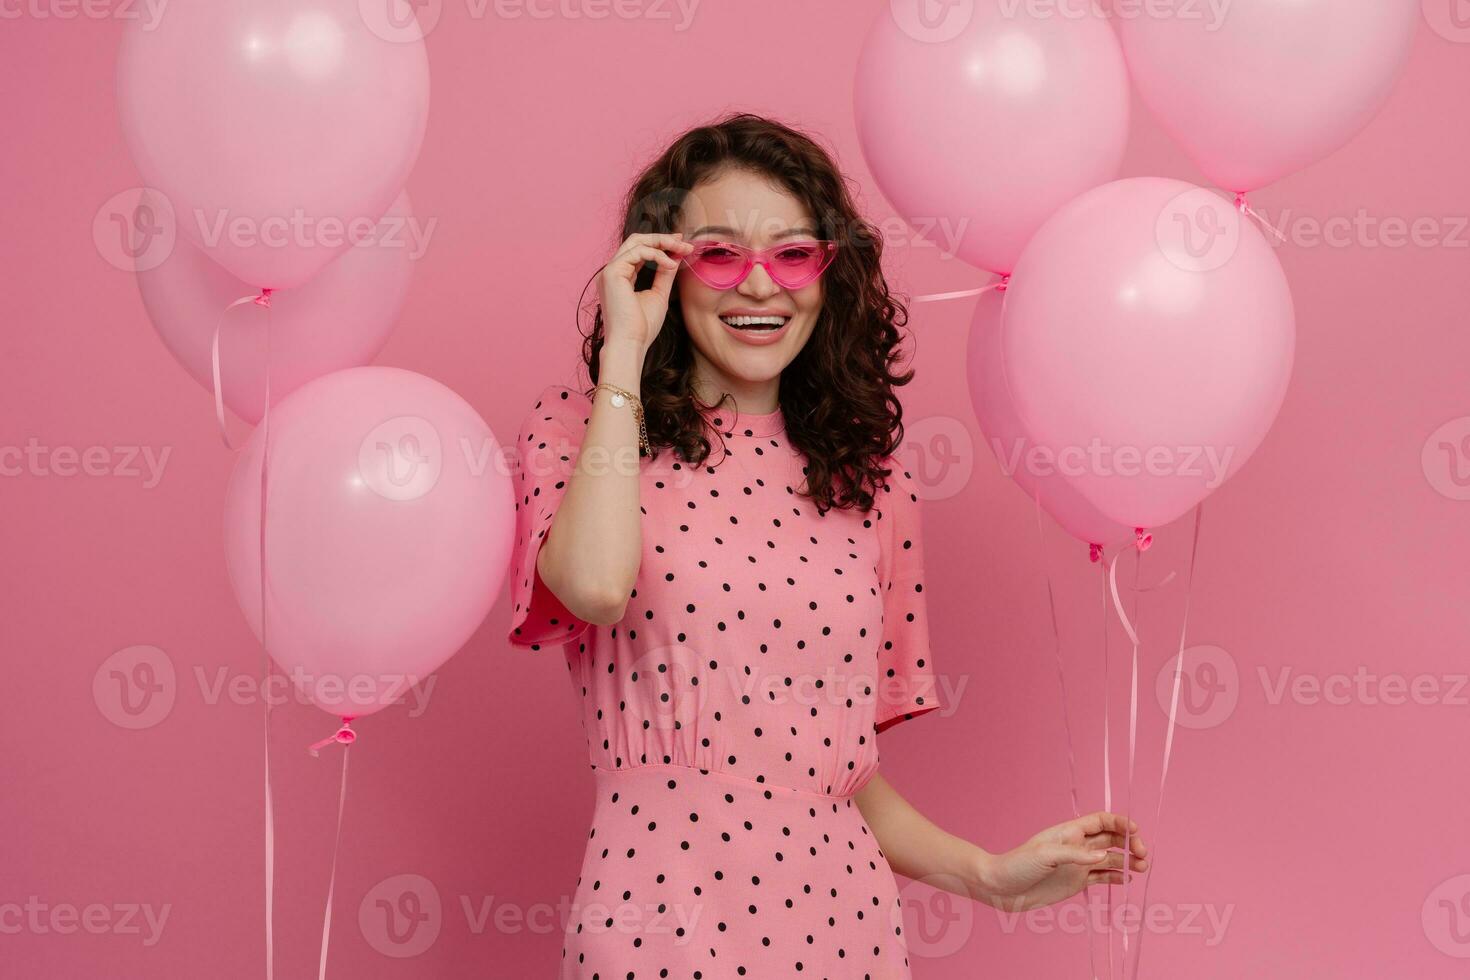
[873,457,944,732]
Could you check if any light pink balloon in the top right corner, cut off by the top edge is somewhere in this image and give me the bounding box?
[1117,0,1420,191]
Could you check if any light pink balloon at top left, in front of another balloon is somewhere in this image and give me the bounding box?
[118,0,429,289]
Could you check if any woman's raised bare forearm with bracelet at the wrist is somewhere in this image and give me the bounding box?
[537,341,644,626]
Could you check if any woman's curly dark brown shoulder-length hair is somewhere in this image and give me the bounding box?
[582,113,913,514]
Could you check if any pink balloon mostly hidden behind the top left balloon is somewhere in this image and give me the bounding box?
[138,194,422,423]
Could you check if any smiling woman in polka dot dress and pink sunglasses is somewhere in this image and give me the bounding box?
[510,113,1147,980]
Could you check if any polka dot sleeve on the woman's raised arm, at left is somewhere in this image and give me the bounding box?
[509,385,592,649]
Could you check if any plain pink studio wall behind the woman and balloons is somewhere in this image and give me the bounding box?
[0,0,1470,980]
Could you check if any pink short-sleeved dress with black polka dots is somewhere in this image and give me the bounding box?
[510,386,942,980]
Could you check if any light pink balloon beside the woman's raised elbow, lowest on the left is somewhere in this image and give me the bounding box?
[225,367,515,717]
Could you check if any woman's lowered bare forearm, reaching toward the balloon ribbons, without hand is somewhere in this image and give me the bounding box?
[854,773,991,902]
